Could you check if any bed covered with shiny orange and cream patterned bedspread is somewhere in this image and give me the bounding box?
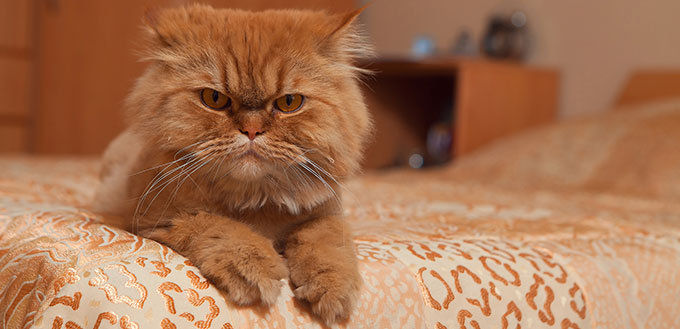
[0,86,680,329]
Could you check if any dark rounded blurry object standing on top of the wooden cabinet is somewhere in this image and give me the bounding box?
[482,11,529,60]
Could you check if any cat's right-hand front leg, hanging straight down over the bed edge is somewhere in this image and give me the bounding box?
[285,217,362,324]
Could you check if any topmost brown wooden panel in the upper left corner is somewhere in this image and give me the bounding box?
[0,0,33,49]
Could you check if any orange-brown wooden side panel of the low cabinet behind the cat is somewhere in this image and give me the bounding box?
[454,61,559,156]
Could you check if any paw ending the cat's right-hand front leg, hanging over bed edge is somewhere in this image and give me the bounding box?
[291,268,361,325]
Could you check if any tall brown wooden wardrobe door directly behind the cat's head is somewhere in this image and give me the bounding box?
[33,0,354,154]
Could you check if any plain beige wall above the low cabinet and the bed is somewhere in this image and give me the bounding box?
[362,0,680,116]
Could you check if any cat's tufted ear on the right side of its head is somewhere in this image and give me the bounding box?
[321,5,374,62]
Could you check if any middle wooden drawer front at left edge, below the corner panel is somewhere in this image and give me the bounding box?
[0,56,31,117]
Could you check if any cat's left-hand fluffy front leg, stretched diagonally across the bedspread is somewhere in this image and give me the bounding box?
[141,212,288,305]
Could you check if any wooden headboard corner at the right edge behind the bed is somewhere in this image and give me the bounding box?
[616,70,680,105]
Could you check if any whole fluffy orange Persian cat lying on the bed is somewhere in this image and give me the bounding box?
[95,5,371,323]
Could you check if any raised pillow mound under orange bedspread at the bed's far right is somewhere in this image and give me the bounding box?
[449,98,680,200]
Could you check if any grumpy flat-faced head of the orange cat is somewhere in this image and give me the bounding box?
[128,5,371,213]
